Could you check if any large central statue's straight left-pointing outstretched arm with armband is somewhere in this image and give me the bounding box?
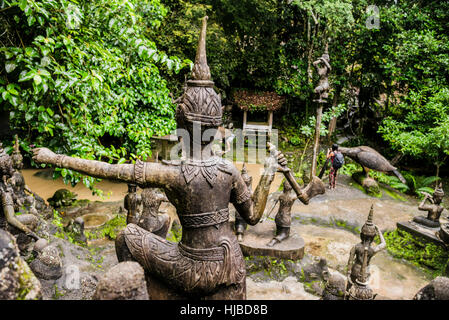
[33,148,172,187]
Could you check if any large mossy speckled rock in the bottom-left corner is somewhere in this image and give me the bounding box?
[0,229,42,300]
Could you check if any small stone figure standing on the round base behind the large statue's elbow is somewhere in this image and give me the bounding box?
[267,180,297,247]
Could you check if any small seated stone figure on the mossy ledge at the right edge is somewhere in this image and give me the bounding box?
[413,184,444,228]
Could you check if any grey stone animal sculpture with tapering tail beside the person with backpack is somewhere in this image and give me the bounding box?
[338,146,407,183]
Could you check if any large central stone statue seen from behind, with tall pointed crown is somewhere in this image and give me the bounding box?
[33,17,292,299]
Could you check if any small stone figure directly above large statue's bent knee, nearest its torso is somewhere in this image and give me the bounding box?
[137,188,170,238]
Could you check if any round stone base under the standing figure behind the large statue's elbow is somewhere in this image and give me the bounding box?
[240,220,305,260]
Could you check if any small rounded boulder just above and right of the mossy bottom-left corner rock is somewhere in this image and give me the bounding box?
[30,245,62,280]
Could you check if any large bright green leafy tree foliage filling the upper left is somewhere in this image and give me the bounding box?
[0,0,190,192]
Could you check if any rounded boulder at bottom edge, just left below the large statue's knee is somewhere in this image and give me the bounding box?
[93,261,149,300]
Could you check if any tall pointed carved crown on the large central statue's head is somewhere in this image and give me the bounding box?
[176,16,223,127]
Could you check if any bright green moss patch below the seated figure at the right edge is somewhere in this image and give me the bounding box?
[385,229,449,277]
